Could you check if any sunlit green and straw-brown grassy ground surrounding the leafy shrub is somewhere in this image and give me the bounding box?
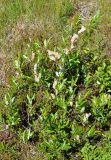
[0,0,111,160]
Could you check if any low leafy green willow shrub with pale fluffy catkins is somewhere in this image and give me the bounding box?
[5,21,111,159]
